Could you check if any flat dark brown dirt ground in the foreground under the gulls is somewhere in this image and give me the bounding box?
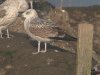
[0,33,75,75]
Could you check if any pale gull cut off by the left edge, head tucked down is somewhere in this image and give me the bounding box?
[0,0,28,38]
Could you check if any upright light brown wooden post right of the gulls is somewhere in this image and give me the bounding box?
[76,23,93,75]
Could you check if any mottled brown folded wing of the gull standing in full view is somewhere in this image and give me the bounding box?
[29,18,58,38]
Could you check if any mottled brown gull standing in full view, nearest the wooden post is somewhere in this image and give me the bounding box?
[22,9,76,54]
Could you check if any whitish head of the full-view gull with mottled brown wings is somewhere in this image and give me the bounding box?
[22,9,38,19]
